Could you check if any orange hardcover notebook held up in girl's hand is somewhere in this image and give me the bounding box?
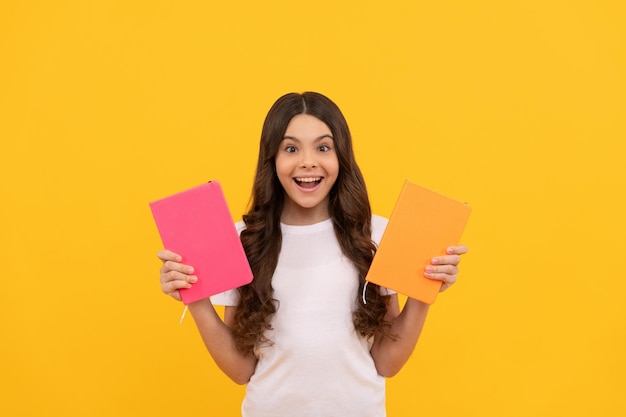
[366,181,472,304]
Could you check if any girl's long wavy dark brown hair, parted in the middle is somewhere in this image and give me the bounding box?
[233,92,389,353]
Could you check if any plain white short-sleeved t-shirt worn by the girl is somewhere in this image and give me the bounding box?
[212,216,387,417]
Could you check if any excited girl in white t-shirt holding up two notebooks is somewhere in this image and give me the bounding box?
[158,92,467,417]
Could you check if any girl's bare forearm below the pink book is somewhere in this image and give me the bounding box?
[189,299,257,384]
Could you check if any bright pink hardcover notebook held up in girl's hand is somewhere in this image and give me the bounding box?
[149,181,252,305]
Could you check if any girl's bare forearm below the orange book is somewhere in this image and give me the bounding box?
[371,298,429,377]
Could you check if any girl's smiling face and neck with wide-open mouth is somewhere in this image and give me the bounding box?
[275,114,339,225]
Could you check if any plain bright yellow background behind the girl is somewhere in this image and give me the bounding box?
[0,0,626,417]
